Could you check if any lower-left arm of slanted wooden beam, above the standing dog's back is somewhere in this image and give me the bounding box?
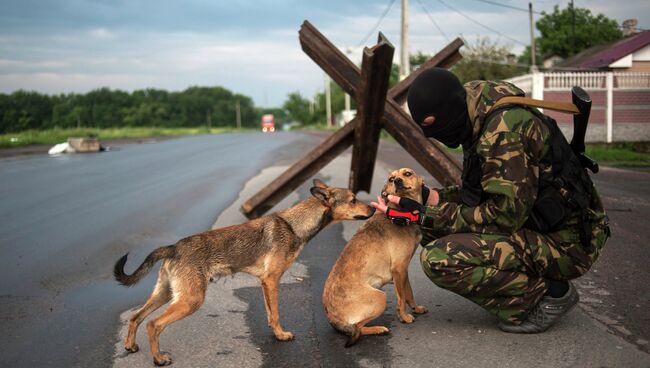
[240,118,357,218]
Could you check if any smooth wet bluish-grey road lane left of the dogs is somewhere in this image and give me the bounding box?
[0,134,298,367]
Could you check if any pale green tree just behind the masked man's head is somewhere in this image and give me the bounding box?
[451,37,523,83]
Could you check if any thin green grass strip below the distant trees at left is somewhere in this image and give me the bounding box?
[0,127,251,148]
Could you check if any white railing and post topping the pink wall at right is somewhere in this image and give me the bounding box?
[506,72,650,143]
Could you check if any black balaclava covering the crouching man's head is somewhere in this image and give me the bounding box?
[407,68,472,148]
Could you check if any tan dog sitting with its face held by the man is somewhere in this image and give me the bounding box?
[323,168,427,347]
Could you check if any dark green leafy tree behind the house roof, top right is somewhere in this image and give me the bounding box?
[529,3,623,60]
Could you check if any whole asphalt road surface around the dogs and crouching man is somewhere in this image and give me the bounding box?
[0,133,650,367]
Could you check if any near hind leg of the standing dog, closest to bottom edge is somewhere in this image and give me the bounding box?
[147,283,206,366]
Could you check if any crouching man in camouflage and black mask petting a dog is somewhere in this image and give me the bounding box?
[374,68,609,333]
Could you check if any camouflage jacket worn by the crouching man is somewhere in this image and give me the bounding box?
[422,81,605,241]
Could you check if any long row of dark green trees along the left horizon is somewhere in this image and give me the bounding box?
[0,87,265,134]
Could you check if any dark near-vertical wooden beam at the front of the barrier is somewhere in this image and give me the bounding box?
[349,33,395,193]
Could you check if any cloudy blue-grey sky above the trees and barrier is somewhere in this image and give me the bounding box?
[0,0,650,106]
